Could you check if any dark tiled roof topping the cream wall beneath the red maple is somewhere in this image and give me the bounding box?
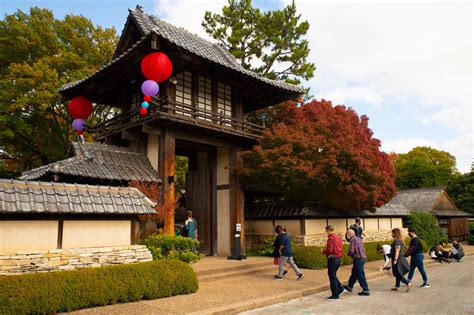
[245,201,409,219]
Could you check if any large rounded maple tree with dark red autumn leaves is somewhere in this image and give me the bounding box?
[242,100,396,209]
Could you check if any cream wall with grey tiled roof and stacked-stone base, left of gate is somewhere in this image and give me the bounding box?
[0,179,156,275]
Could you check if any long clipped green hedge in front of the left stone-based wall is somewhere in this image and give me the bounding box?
[0,260,198,314]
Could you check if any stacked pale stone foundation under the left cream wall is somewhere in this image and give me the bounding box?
[0,245,152,275]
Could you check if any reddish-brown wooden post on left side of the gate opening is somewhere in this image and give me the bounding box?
[158,128,175,235]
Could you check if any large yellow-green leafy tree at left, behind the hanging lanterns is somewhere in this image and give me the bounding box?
[0,7,117,176]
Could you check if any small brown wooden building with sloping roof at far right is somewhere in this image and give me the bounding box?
[390,187,471,240]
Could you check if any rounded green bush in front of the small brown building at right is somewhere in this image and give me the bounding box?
[406,211,446,246]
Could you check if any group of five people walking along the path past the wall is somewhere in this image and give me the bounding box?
[274,219,436,300]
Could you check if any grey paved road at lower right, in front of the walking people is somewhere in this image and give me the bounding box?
[243,256,474,315]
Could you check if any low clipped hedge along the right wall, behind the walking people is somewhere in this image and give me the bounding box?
[294,238,429,269]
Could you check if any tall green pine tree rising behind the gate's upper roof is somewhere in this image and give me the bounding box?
[202,0,316,84]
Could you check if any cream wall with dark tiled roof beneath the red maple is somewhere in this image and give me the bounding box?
[245,201,409,248]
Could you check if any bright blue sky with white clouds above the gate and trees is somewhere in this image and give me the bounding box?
[0,0,474,173]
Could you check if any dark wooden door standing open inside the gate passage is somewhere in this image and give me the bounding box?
[186,169,213,255]
